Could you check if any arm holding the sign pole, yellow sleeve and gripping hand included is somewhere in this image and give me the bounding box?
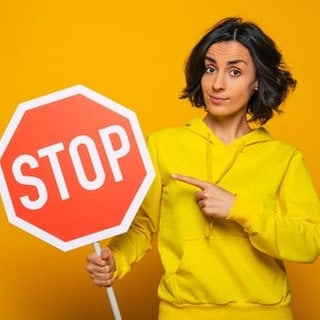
[87,136,162,286]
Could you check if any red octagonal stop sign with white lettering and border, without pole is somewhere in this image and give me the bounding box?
[0,85,154,251]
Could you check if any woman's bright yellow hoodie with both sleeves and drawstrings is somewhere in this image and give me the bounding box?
[110,118,320,320]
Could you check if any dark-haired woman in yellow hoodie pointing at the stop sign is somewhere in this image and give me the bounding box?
[87,18,320,320]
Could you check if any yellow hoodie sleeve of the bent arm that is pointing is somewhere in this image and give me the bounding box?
[228,150,320,262]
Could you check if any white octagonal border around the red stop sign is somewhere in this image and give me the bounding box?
[0,85,155,251]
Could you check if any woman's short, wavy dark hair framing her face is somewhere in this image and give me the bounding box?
[180,17,296,124]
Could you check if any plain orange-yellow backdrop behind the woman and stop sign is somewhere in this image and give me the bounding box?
[0,0,320,320]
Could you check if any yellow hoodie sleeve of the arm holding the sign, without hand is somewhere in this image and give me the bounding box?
[109,139,162,278]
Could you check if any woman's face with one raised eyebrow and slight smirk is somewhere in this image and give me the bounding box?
[201,41,258,120]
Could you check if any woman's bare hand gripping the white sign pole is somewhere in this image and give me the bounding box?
[86,247,116,287]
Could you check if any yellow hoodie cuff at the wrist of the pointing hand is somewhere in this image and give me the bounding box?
[227,195,261,231]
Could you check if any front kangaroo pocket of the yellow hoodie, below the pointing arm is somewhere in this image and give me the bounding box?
[174,237,289,305]
